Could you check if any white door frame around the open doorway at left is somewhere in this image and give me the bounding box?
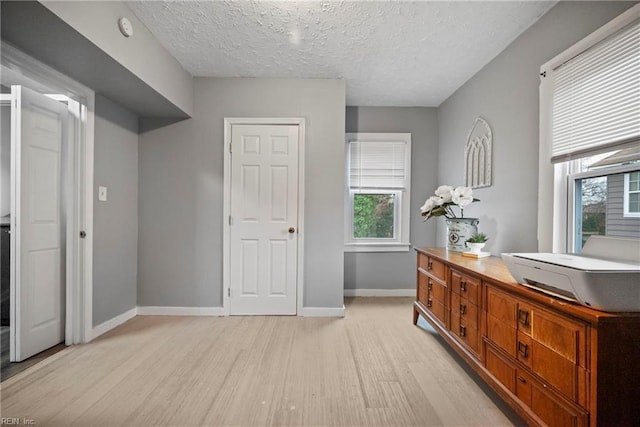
[0,42,95,345]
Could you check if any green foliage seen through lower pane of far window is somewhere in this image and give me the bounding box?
[353,194,396,239]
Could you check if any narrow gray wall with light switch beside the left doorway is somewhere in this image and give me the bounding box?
[93,95,138,326]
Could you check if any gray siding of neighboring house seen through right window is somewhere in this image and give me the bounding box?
[606,173,640,238]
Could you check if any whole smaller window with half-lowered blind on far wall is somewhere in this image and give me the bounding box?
[345,133,411,252]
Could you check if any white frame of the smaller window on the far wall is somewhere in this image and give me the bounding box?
[344,132,411,252]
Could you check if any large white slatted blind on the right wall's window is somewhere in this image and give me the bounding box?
[549,20,640,162]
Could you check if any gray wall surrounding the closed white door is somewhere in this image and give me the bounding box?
[138,78,345,308]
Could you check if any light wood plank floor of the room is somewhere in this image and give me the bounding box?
[1,298,522,426]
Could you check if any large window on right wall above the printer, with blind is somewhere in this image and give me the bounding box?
[538,6,640,252]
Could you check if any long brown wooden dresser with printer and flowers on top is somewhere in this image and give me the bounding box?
[413,248,640,427]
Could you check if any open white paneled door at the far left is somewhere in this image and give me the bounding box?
[10,86,67,361]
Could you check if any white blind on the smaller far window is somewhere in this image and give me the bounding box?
[349,140,407,189]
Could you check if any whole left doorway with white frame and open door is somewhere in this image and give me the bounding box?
[0,42,94,380]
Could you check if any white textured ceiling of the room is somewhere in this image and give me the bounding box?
[128,0,555,106]
